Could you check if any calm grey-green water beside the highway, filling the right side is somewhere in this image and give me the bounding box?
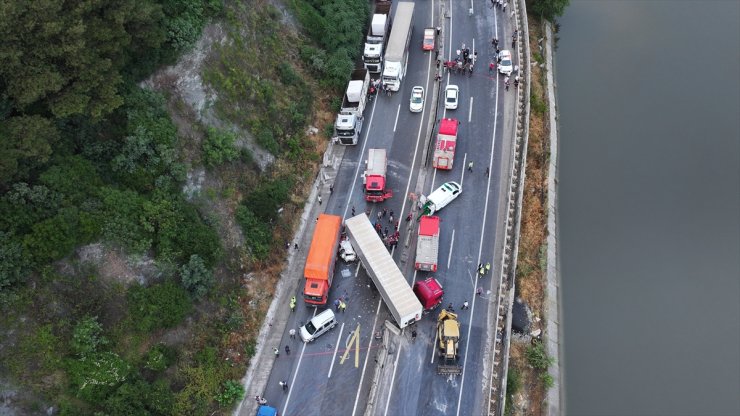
[556,0,740,416]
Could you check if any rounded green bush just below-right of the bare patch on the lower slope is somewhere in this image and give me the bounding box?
[127,281,193,332]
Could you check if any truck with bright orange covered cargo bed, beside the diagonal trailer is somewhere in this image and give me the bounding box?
[303,214,342,305]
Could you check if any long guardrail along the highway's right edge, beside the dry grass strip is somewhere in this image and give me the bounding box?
[488,0,532,415]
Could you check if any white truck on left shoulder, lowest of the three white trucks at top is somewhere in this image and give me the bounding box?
[333,68,370,144]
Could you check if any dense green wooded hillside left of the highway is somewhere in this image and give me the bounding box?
[0,0,368,415]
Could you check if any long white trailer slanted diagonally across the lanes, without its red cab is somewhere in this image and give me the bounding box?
[344,213,423,328]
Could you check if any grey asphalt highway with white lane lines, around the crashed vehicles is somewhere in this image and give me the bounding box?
[264,1,514,416]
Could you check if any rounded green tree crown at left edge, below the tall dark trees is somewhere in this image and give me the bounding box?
[0,114,59,186]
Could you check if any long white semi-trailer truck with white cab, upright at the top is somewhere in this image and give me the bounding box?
[383,1,414,91]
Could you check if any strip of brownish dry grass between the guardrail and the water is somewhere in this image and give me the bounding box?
[509,22,549,415]
